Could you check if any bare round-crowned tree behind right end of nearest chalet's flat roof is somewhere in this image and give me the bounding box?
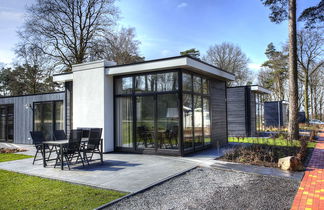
[202,42,250,86]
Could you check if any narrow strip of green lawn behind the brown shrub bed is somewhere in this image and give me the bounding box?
[228,137,316,148]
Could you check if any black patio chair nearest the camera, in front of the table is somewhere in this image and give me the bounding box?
[54,130,84,170]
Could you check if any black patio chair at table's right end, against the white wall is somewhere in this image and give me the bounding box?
[82,128,103,165]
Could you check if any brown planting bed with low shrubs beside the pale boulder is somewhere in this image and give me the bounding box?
[218,144,313,168]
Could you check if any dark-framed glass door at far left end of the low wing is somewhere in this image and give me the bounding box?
[0,104,14,142]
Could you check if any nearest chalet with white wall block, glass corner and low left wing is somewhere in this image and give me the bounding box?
[0,56,235,155]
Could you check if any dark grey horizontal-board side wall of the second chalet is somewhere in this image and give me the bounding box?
[227,87,247,136]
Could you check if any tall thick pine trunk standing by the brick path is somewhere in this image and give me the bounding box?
[288,0,299,140]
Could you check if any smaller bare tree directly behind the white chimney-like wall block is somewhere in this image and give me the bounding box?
[90,28,144,64]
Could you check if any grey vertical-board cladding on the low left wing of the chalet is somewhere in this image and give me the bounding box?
[0,92,65,144]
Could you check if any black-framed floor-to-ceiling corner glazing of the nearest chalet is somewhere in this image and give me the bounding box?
[115,71,211,154]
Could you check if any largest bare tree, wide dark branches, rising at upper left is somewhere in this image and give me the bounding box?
[20,0,118,71]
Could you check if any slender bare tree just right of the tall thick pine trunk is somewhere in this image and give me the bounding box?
[297,30,324,119]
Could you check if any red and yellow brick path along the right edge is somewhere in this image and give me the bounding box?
[291,130,324,210]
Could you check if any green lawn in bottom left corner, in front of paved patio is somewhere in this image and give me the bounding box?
[0,170,126,209]
